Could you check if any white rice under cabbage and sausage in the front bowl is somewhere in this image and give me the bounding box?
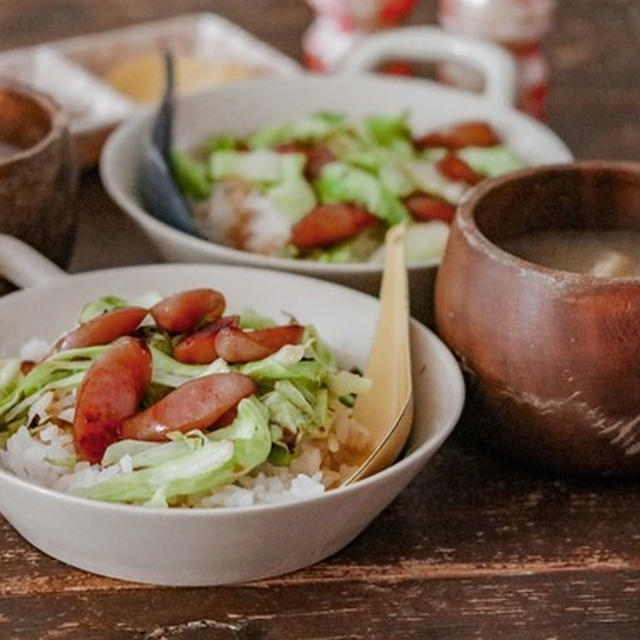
[0,391,368,508]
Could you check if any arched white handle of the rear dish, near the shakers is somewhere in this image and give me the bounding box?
[339,27,517,106]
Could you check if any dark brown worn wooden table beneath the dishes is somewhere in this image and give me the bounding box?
[0,0,640,640]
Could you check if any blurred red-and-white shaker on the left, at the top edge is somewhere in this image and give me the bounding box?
[302,0,416,73]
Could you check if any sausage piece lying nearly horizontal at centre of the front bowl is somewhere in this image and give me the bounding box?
[122,373,256,441]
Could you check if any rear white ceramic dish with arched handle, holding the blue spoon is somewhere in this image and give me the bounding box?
[101,27,571,321]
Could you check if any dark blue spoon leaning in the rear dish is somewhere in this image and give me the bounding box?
[140,53,198,235]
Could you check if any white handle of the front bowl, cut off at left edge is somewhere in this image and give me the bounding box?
[0,233,67,287]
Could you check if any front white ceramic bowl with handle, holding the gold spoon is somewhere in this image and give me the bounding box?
[0,236,464,586]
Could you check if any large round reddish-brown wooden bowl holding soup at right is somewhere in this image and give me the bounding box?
[435,161,640,474]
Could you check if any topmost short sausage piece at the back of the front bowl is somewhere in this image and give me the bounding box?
[151,289,226,333]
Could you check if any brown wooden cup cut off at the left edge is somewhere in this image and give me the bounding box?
[0,83,77,284]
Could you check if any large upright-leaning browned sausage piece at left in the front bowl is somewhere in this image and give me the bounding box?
[73,337,151,463]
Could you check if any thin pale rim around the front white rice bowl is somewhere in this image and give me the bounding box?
[0,263,465,517]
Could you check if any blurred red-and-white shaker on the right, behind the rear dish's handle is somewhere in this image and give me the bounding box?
[438,0,556,118]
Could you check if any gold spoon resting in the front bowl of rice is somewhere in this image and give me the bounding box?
[343,225,413,484]
